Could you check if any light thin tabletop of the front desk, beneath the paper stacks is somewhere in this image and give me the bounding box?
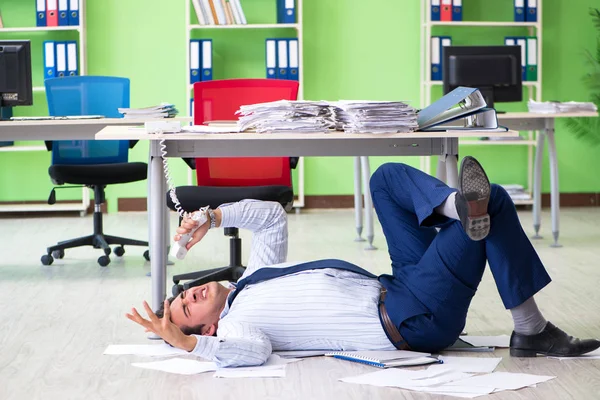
[96,126,519,141]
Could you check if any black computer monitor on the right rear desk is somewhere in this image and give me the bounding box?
[442,46,523,107]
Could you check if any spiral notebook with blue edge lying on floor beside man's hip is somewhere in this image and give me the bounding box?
[325,350,442,368]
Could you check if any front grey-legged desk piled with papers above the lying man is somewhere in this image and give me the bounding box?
[96,126,518,310]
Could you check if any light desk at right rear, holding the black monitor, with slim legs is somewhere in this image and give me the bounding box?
[354,112,598,249]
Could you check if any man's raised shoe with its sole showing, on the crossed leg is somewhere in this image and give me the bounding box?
[456,156,491,240]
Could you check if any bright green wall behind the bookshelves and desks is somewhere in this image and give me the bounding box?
[0,0,600,211]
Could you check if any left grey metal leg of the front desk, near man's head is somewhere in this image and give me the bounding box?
[148,144,167,310]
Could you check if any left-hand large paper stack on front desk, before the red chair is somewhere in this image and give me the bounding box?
[236,100,335,133]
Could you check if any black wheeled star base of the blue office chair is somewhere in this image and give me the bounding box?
[42,233,148,267]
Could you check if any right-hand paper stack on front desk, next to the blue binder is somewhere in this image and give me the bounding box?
[334,100,418,133]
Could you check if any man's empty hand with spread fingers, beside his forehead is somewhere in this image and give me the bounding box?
[125,300,197,351]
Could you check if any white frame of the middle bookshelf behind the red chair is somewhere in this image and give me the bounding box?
[185,0,304,212]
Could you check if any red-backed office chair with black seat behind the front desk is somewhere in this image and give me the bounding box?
[167,79,298,295]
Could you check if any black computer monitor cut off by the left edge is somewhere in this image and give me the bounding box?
[0,40,33,111]
